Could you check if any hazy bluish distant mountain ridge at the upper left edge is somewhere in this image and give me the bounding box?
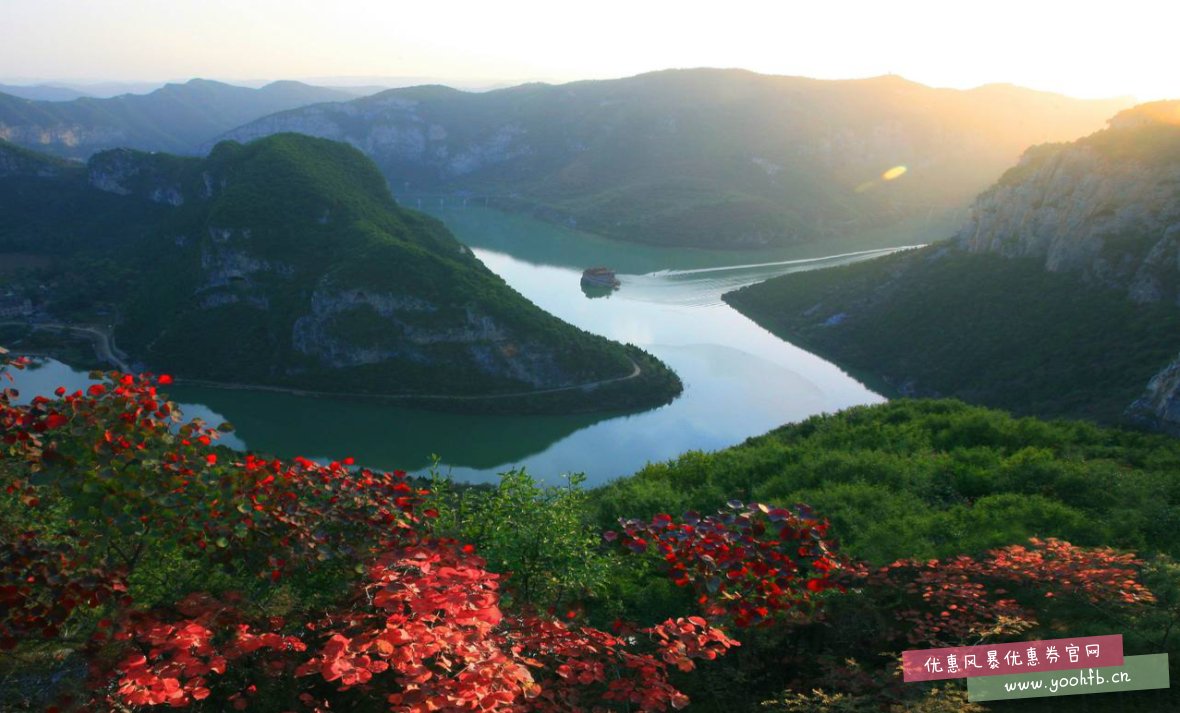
[0,79,355,158]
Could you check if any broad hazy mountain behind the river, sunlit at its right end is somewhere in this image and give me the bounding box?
[227,70,1128,247]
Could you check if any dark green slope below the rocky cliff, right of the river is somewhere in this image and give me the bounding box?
[726,246,1180,423]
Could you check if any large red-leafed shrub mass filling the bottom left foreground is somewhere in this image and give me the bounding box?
[0,365,736,711]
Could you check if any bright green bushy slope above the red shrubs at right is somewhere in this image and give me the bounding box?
[594,399,1180,563]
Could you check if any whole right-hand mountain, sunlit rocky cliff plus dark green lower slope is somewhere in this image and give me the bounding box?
[726,103,1180,431]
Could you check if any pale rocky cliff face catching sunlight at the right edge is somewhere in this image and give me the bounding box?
[957,102,1180,305]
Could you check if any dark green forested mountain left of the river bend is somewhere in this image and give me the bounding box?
[0,135,680,410]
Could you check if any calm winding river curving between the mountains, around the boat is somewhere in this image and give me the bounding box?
[4,202,901,484]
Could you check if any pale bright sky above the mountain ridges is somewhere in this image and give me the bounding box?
[0,0,1180,100]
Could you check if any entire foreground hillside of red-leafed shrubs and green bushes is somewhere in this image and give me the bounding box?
[0,365,1180,713]
